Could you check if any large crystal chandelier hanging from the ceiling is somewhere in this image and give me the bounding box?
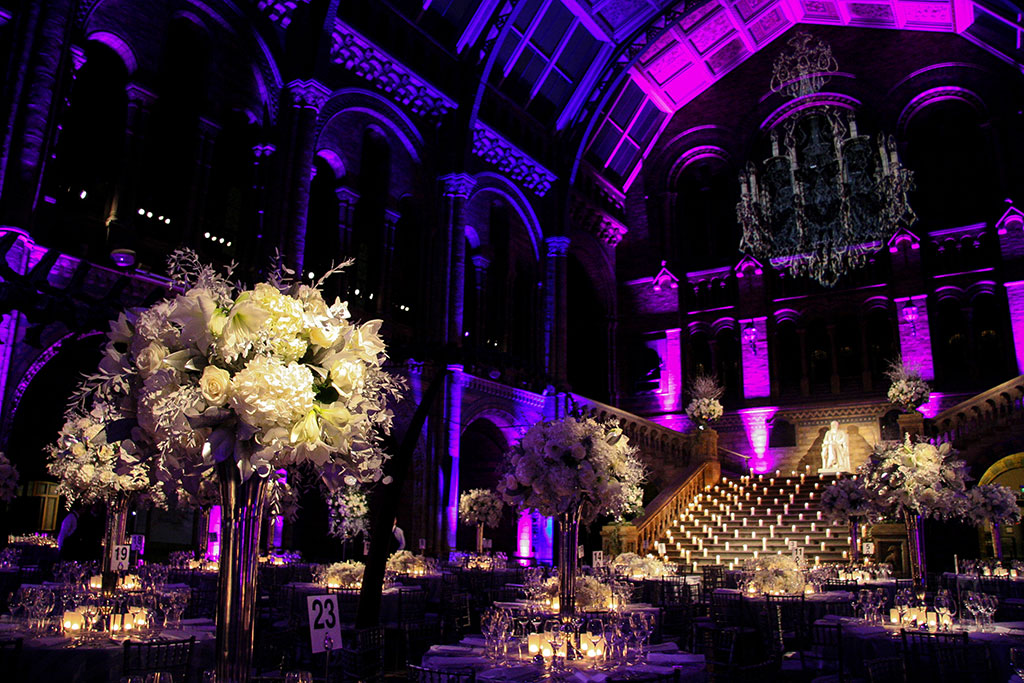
[736,33,916,287]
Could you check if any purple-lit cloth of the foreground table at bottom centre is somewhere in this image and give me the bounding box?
[421,636,708,683]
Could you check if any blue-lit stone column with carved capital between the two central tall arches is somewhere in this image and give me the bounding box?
[439,173,476,345]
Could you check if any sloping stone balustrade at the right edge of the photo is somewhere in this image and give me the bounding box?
[927,375,1024,443]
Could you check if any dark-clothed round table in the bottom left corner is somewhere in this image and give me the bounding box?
[0,620,216,683]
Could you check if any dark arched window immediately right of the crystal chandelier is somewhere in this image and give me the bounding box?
[903,99,1000,229]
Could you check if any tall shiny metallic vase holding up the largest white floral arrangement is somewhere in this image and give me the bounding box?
[216,461,266,683]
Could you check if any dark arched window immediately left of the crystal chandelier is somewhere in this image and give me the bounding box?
[675,156,739,269]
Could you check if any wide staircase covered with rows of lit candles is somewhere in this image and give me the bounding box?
[639,464,850,571]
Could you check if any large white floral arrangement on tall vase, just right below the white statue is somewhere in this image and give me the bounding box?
[861,434,968,519]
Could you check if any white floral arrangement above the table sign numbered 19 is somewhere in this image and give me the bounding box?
[46,405,151,508]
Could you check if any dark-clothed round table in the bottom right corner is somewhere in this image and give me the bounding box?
[820,616,1024,681]
